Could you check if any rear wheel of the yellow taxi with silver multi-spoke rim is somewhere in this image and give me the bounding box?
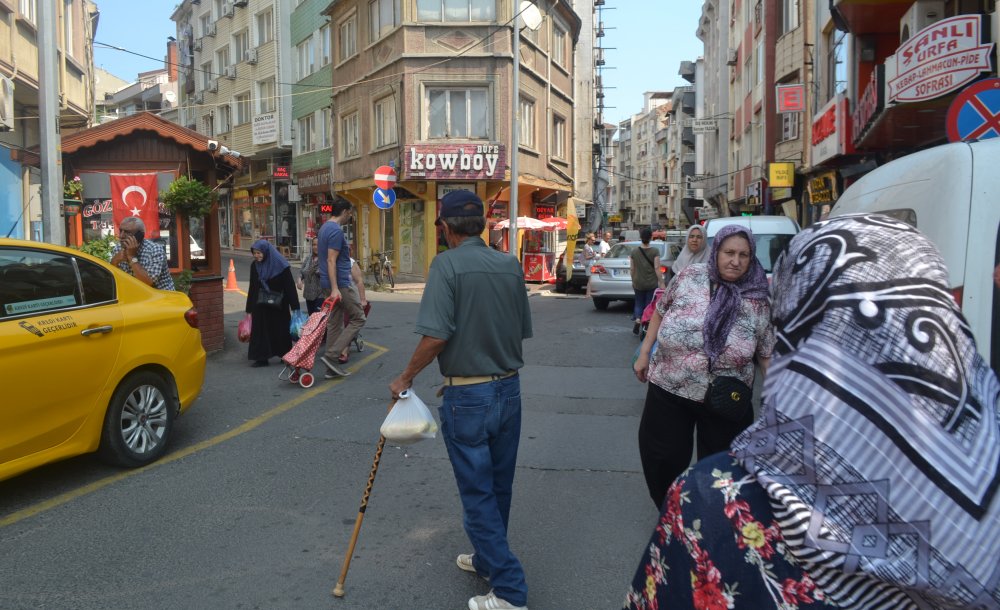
[98,371,177,468]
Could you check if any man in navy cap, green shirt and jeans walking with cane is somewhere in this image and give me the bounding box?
[389,191,532,610]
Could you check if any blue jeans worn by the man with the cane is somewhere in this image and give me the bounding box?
[439,375,528,606]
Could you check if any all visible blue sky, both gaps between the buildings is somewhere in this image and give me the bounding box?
[94,0,702,123]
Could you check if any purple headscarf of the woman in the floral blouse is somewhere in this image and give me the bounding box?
[702,224,769,365]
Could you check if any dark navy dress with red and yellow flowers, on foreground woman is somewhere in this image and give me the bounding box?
[624,453,836,610]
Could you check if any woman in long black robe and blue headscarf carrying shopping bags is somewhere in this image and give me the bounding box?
[246,239,299,367]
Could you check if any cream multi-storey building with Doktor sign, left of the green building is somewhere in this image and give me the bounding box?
[171,0,292,256]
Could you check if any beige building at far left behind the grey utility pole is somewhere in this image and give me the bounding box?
[0,0,97,241]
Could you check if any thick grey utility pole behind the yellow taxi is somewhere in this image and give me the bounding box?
[37,0,66,246]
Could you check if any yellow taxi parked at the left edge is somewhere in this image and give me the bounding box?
[0,239,205,480]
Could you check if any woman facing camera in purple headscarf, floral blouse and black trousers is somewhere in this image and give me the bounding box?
[633,224,774,508]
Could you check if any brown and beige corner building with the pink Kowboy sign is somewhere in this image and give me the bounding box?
[325,0,591,278]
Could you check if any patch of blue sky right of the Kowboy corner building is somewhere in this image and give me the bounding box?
[595,0,703,124]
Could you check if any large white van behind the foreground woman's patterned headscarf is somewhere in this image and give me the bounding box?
[830,138,1000,370]
